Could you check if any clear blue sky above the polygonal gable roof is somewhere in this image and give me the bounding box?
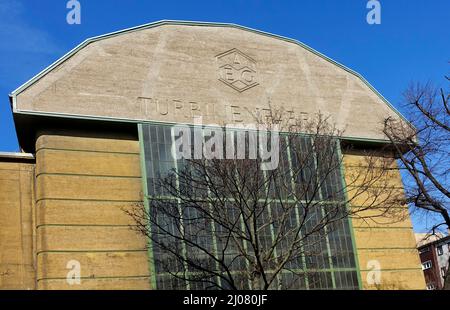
[0,0,450,230]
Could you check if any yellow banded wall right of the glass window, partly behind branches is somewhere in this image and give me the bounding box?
[344,153,425,289]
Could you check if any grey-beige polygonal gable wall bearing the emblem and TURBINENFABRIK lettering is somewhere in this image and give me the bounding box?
[16,24,398,139]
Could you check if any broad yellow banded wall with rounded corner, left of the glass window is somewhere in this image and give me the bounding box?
[36,135,150,289]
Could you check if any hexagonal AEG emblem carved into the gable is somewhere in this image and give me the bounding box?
[216,48,259,92]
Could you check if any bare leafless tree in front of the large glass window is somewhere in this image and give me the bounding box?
[128,108,399,290]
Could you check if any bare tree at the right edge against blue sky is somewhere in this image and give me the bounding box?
[384,77,450,289]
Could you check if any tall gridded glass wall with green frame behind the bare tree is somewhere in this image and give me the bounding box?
[139,123,359,290]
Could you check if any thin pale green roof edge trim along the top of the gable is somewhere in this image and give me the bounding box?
[9,20,409,124]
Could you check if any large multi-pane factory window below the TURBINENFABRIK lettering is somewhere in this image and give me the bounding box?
[139,124,359,290]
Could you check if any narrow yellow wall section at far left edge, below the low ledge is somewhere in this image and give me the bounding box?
[0,162,36,290]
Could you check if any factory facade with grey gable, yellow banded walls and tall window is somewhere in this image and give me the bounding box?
[0,21,425,290]
